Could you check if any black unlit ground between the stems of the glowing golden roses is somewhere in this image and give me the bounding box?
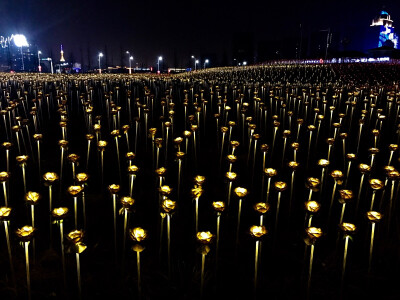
[0,66,400,299]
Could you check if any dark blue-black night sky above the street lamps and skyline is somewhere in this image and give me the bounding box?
[0,0,400,66]
